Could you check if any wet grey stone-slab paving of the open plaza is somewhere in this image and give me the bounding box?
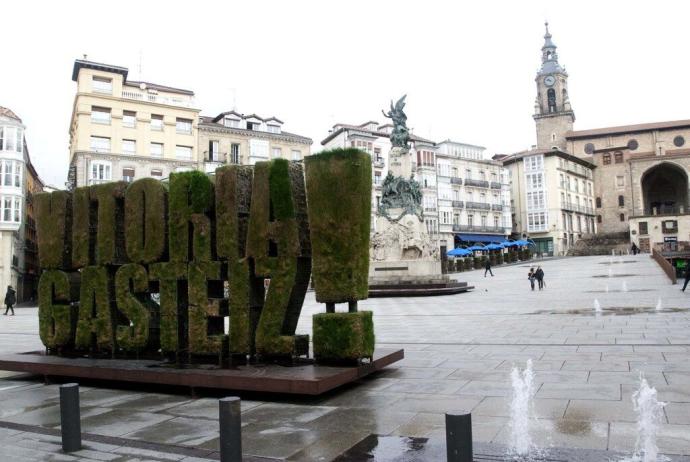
[0,255,690,462]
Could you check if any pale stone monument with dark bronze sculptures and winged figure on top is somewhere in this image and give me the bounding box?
[369,96,467,296]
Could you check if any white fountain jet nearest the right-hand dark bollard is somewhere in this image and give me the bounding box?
[509,359,535,456]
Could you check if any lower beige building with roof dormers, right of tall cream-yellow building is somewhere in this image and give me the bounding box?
[198,111,312,172]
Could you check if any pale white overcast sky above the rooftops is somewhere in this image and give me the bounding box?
[0,0,690,186]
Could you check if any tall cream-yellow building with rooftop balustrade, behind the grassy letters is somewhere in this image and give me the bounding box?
[68,59,199,187]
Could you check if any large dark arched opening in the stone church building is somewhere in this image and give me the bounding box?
[642,162,688,215]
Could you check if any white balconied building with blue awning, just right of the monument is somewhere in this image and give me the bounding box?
[436,140,512,247]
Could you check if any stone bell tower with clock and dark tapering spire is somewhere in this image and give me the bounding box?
[532,22,575,151]
